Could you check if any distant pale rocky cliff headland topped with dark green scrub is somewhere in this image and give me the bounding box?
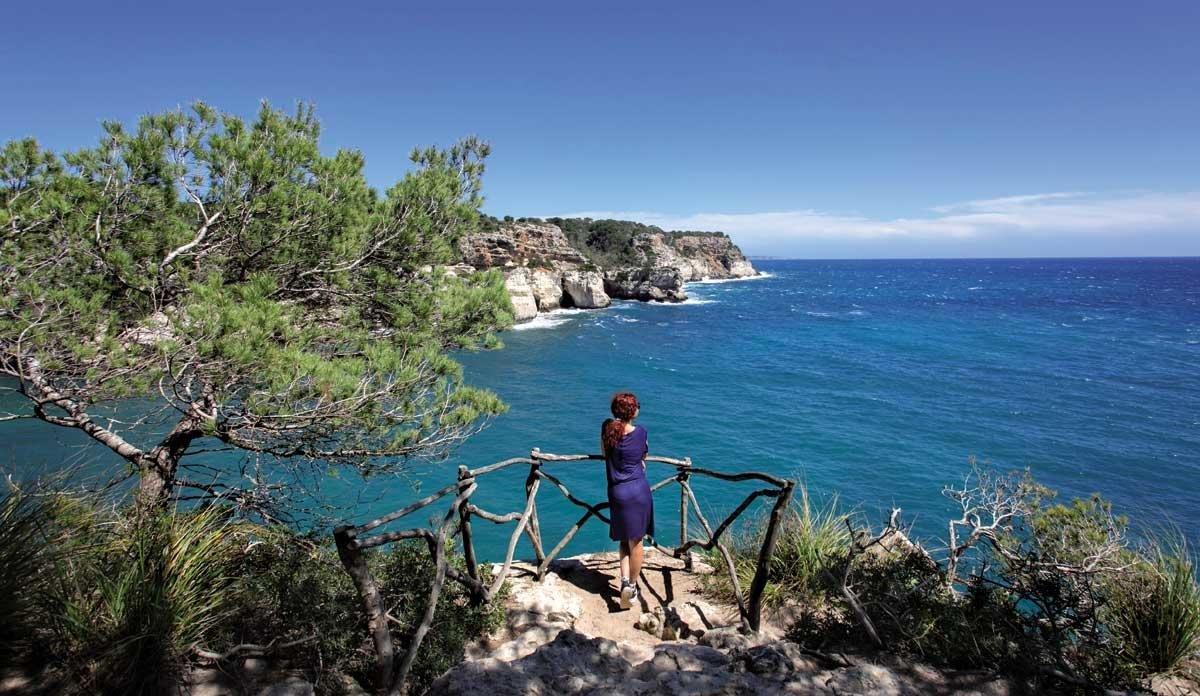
[458,217,757,322]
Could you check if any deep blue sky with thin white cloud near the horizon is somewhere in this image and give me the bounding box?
[0,0,1200,258]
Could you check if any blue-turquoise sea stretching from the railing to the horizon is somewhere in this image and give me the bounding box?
[0,259,1200,559]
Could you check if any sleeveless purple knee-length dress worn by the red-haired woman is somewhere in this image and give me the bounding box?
[605,421,654,541]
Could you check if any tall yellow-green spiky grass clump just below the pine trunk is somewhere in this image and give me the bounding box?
[44,505,233,694]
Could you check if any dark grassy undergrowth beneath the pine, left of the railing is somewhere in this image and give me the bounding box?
[0,493,504,695]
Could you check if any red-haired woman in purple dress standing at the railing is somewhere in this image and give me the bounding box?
[600,391,654,608]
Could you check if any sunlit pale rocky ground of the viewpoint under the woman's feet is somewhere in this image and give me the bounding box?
[428,551,1016,696]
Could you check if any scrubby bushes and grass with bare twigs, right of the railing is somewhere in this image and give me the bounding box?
[729,473,1200,691]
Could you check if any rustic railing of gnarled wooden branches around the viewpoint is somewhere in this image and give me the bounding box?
[334,449,796,695]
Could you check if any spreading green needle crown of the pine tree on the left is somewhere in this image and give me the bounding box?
[0,103,511,506]
